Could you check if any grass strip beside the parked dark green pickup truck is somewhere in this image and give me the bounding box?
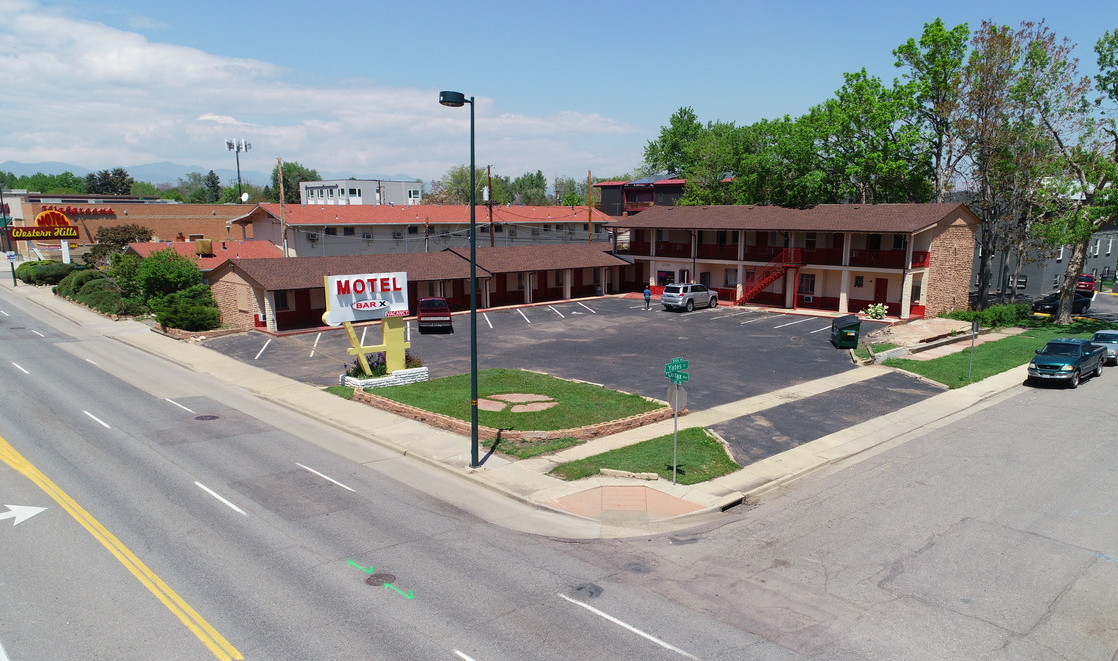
[884,320,1114,388]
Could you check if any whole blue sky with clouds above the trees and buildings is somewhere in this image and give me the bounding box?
[0,0,1118,183]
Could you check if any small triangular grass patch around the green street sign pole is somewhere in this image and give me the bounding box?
[550,427,741,484]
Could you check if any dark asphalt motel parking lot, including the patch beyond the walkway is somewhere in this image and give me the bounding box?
[206,298,940,463]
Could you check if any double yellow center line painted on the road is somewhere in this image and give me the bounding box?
[0,437,244,661]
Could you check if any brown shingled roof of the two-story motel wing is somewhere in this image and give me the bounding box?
[617,202,978,234]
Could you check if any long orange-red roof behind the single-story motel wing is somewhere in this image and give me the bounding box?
[233,204,614,227]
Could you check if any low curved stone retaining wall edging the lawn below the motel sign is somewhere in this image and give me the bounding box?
[353,391,686,441]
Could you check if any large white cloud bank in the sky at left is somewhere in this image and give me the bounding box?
[0,0,644,179]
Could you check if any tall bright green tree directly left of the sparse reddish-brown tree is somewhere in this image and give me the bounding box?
[893,18,970,202]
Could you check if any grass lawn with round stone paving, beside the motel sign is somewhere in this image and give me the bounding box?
[366,369,661,433]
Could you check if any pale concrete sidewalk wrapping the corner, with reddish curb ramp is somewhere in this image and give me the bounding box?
[3,283,1025,537]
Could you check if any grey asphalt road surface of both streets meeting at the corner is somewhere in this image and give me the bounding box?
[0,290,1118,661]
